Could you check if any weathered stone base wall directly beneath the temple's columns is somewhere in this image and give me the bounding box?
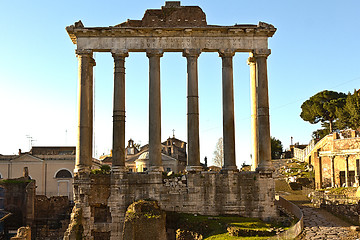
[65,172,277,239]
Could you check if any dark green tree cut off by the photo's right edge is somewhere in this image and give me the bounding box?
[336,90,360,130]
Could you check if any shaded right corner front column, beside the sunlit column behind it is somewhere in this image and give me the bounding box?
[254,49,274,172]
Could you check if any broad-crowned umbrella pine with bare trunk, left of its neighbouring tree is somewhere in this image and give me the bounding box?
[300,90,346,132]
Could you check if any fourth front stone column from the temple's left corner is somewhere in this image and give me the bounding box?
[183,49,202,171]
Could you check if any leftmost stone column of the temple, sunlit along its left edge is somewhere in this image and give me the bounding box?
[75,50,95,172]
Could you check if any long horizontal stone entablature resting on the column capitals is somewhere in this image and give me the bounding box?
[66,21,276,52]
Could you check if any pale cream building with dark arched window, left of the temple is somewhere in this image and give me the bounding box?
[0,147,100,200]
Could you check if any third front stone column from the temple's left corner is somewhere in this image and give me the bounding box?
[146,49,164,172]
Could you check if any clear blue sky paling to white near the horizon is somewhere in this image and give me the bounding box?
[0,0,360,165]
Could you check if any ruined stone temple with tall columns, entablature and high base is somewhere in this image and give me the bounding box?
[64,2,277,239]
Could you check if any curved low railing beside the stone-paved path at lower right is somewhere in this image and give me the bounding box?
[269,196,304,240]
